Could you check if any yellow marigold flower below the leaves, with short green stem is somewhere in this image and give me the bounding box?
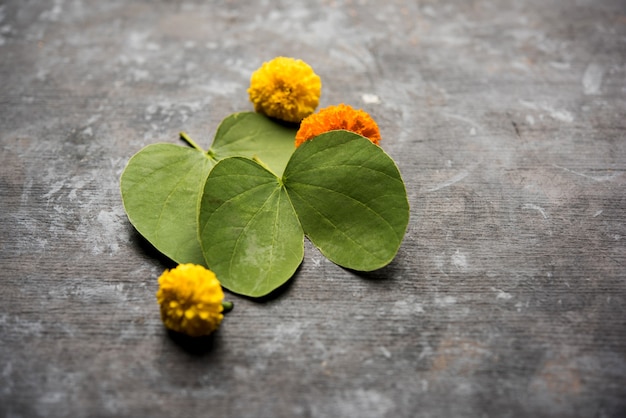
[156,264,224,337]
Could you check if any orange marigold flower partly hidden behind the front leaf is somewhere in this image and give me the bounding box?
[296,103,380,147]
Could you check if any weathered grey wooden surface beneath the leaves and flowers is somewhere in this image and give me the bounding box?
[0,0,626,417]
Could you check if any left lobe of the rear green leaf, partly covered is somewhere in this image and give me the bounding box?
[120,144,215,264]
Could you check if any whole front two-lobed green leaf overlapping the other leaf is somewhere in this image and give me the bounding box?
[199,131,409,297]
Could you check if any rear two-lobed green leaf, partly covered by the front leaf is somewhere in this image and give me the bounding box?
[120,112,296,264]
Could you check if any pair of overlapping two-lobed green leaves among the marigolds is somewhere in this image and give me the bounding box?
[121,112,409,297]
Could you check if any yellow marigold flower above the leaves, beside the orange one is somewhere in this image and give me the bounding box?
[248,57,322,123]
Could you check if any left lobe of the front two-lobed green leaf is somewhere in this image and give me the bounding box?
[199,157,304,297]
